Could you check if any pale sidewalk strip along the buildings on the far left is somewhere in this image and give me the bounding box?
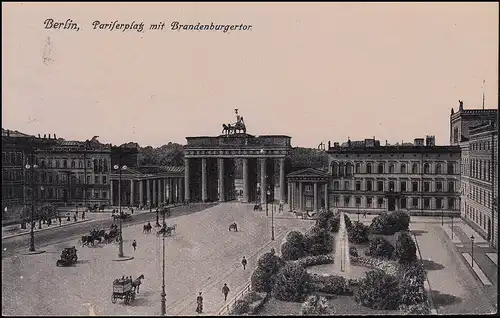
[2,204,180,240]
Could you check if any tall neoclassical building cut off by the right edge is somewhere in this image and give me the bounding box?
[450,102,498,248]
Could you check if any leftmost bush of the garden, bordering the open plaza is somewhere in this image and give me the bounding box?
[251,252,285,293]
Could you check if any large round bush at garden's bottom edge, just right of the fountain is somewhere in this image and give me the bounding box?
[354,271,400,310]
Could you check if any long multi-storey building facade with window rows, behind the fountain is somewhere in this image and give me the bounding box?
[327,136,460,215]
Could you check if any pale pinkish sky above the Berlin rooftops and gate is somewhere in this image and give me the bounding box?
[2,3,499,147]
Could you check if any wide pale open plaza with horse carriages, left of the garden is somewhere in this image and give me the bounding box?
[2,203,312,315]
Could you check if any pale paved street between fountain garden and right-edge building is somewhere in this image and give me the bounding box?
[350,214,498,314]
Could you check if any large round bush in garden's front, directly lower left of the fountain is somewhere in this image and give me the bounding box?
[272,263,311,301]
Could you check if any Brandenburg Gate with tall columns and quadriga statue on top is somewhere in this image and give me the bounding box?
[184,109,291,204]
